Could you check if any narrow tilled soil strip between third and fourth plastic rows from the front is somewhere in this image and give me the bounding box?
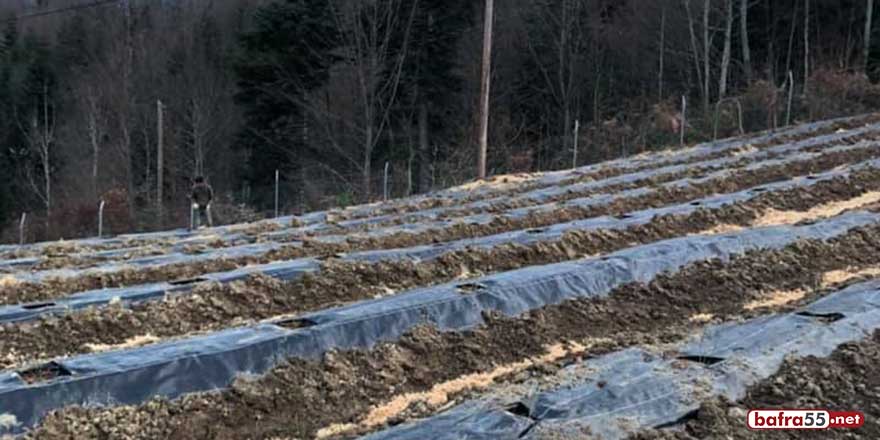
[0,138,880,304]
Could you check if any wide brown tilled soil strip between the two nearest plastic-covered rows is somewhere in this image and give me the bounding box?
[22,226,880,439]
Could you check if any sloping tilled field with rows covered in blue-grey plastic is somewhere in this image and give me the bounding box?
[0,114,880,440]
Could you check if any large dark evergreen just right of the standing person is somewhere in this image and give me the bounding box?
[236,0,338,211]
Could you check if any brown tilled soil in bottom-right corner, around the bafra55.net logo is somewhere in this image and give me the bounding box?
[633,331,880,440]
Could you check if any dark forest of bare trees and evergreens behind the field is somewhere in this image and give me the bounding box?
[0,0,880,240]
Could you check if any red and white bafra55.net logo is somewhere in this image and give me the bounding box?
[748,409,865,430]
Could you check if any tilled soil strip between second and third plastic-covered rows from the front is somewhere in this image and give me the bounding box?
[0,170,880,368]
